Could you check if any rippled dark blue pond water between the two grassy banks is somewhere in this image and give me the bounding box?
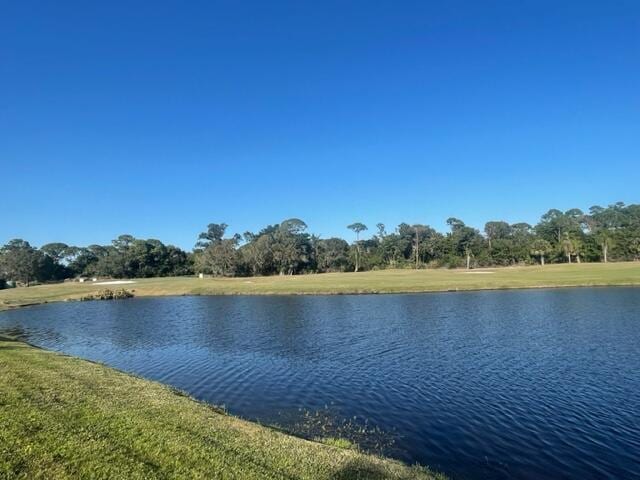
[0,288,640,479]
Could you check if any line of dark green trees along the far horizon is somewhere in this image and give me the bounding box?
[0,202,640,288]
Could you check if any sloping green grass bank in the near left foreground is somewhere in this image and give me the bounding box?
[0,337,438,479]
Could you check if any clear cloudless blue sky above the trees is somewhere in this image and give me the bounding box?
[0,0,640,248]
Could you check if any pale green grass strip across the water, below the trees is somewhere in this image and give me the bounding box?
[0,262,640,310]
